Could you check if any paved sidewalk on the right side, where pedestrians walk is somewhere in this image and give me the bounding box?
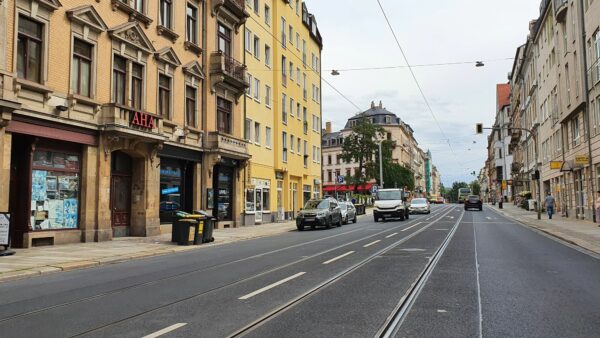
[488,203,600,255]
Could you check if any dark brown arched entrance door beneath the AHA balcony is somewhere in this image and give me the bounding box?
[110,152,132,237]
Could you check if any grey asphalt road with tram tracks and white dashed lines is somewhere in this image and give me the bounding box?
[0,205,600,337]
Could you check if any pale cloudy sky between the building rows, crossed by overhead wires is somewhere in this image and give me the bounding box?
[306,0,540,186]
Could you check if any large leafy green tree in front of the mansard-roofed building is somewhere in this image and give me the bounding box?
[341,118,385,190]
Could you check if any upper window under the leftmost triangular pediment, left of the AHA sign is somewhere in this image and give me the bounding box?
[71,39,93,97]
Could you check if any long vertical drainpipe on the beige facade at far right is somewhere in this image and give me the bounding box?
[579,0,598,223]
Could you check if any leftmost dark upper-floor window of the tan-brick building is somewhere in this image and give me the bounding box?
[17,16,43,83]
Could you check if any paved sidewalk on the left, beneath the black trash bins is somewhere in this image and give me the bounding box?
[0,221,296,282]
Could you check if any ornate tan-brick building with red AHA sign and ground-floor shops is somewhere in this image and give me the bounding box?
[0,0,250,247]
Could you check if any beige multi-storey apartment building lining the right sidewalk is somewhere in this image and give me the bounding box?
[500,0,600,219]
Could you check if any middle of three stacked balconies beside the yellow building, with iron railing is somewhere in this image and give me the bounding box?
[210,51,249,98]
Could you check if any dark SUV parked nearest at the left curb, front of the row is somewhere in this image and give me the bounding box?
[296,198,343,231]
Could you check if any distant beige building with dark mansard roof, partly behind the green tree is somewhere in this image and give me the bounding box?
[322,102,439,194]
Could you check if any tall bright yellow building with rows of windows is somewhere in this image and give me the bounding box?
[243,0,322,224]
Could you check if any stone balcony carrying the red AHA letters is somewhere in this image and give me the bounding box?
[99,103,165,140]
